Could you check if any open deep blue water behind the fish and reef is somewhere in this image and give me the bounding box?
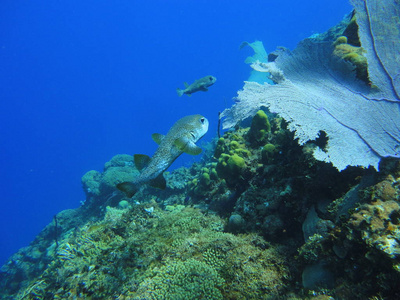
[0,0,351,264]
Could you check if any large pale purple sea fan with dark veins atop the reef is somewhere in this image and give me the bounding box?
[222,0,400,171]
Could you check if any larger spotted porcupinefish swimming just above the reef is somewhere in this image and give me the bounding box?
[117,115,208,198]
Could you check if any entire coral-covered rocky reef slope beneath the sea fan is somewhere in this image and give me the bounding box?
[0,110,400,300]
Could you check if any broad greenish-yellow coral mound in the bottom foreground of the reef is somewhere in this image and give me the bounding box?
[1,203,288,299]
